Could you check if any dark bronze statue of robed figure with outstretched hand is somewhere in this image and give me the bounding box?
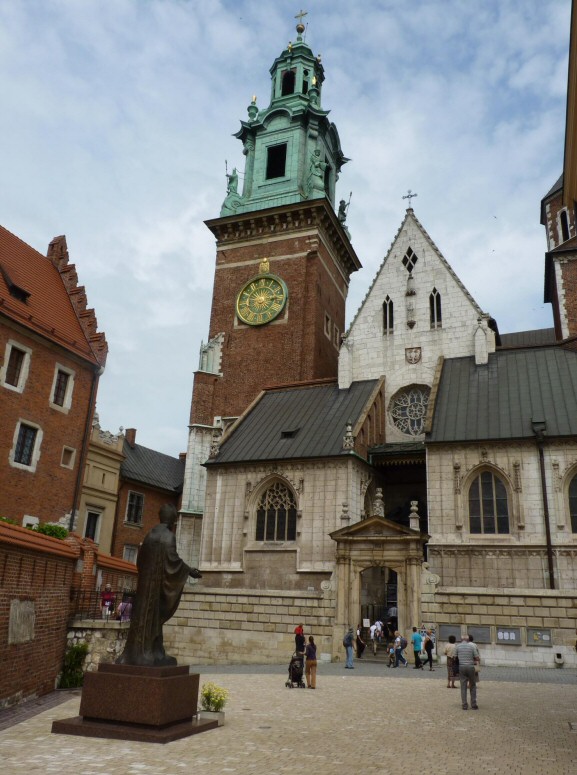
[116,503,201,667]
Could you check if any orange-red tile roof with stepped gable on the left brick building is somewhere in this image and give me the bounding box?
[0,226,108,366]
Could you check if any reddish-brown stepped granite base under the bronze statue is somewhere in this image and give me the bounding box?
[52,664,218,743]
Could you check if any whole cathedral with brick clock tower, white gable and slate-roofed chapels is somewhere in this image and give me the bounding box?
[166,10,577,666]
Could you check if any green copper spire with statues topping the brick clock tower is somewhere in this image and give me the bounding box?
[220,18,348,216]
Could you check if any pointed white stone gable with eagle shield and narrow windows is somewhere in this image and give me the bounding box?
[339,209,495,442]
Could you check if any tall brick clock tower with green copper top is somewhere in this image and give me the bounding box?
[180,18,361,559]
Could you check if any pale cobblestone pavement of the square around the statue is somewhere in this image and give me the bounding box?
[0,662,577,775]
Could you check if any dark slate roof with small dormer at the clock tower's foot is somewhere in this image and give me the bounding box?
[208,379,379,464]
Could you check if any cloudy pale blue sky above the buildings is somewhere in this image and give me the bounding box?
[0,0,571,455]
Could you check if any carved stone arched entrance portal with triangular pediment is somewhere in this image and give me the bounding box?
[331,517,427,656]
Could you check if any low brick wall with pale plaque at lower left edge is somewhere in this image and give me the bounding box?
[0,523,78,706]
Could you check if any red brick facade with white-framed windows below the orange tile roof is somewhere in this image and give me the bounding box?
[0,323,93,522]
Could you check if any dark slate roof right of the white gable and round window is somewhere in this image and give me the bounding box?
[427,347,577,443]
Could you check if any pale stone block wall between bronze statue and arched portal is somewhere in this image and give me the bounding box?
[164,588,344,665]
